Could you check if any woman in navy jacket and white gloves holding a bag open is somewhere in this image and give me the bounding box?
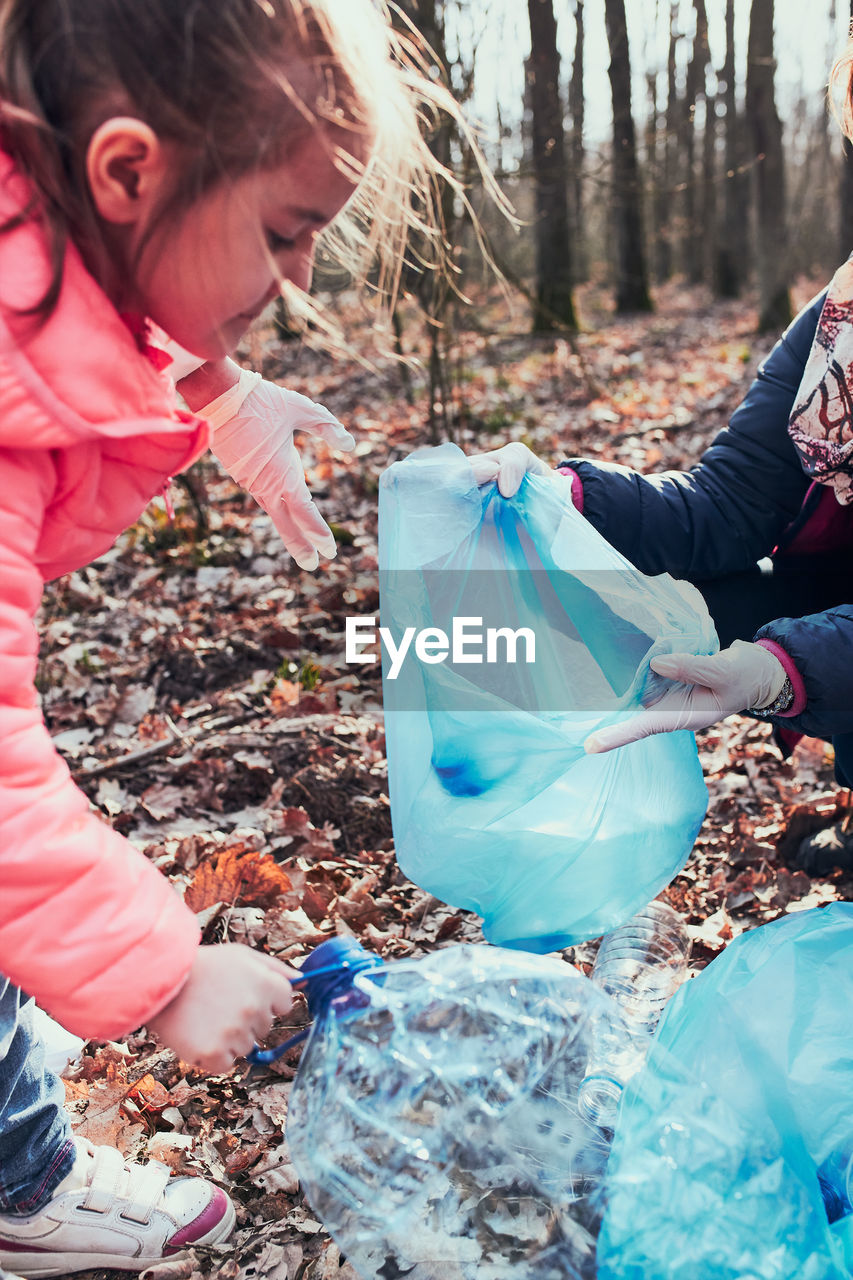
[471,282,853,786]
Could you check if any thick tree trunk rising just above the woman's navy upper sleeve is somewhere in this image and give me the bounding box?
[747,0,792,332]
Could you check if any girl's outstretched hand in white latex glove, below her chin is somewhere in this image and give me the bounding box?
[199,369,355,568]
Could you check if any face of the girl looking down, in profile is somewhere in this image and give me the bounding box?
[134,136,355,360]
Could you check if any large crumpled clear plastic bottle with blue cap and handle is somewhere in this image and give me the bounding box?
[287,938,621,1280]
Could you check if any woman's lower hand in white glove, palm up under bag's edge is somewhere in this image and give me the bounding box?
[584,640,785,755]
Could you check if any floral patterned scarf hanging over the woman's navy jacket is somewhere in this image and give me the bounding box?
[788,256,853,506]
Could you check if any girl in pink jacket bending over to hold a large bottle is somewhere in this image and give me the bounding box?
[0,0,450,1276]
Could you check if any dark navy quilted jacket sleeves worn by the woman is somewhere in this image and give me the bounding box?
[569,285,853,786]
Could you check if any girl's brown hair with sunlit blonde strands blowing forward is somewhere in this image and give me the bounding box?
[0,0,501,343]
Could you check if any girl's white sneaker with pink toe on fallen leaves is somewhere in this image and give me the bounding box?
[0,1138,236,1277]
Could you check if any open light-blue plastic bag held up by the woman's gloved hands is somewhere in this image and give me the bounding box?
[379,444,717,952]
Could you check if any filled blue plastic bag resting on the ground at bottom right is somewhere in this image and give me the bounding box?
[598,902,853,1280]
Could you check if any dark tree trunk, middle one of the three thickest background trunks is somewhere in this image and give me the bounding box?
[605,0,653,312]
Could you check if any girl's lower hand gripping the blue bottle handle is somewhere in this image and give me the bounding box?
[149,942,298,1073]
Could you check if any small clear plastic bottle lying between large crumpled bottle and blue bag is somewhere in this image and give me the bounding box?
[579,901,690,1129]
